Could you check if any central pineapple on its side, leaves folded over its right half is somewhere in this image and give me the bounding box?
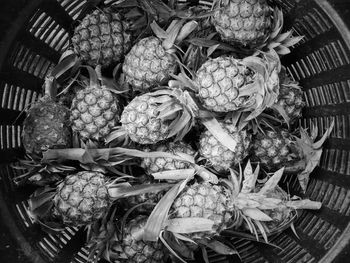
[107,89,198,144]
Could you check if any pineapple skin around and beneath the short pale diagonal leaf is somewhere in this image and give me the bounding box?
[199,123,251,172]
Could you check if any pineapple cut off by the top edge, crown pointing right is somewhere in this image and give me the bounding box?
[211,0,303,55]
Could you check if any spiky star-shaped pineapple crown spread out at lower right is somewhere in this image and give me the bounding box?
[224,160,322,242]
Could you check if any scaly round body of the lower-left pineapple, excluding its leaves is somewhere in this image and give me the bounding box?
[53,171,110,226]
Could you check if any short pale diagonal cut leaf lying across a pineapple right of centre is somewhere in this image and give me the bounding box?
[202,118,237,152]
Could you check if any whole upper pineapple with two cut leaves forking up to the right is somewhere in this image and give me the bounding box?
[123,20,196,90]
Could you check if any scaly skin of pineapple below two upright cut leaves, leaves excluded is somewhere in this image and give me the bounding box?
[123,36,176,90]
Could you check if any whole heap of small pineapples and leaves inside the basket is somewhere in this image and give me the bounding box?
[16,0,333,262]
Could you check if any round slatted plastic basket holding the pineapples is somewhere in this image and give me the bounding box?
[0,0,350,263]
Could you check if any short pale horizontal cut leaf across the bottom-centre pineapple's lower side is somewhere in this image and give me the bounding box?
[165,217,214,234]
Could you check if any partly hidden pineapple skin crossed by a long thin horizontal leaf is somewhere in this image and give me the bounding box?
[141,142,195,174]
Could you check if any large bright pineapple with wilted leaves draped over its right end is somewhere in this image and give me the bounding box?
[194,51,280,117]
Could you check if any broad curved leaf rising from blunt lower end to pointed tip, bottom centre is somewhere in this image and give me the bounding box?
[143,178,189,241]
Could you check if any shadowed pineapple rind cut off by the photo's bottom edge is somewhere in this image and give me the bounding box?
[110,215,166,263]
